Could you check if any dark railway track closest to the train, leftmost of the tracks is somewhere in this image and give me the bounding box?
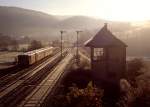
[0,48,60,95]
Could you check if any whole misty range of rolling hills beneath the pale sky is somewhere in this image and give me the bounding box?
[0,6,130,39]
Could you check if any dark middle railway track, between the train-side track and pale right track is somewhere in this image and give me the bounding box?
[0,48,69,107]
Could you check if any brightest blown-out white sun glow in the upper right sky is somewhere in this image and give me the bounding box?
[86,0,150,21]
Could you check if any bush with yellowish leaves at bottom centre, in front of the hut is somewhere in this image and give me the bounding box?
[52,82,103,107]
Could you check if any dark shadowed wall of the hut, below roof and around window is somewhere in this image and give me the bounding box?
[92,47,126,82]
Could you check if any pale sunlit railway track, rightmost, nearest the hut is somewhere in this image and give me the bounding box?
[18,50,73,107]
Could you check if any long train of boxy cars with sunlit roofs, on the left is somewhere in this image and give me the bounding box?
[18,47,58,67]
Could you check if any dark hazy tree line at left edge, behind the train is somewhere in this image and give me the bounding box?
[0,33,43,51]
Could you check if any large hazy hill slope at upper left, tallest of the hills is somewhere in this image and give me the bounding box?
[0,6,59,39]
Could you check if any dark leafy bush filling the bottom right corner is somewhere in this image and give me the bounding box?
[118,80,150,107]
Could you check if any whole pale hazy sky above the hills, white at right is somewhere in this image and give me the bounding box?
[0,0,150,21]
